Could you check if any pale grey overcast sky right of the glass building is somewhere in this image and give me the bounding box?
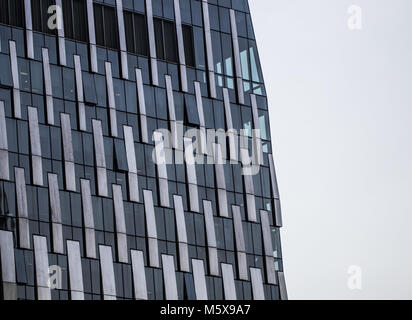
[249,0,412,299]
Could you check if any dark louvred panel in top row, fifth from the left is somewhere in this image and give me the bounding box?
[124,11,149,56]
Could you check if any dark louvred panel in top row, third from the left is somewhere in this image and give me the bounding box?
[63,0,88,42]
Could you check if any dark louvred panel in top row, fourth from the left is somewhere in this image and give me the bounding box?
[94,4,119,49]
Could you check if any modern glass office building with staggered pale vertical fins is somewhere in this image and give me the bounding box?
[0,0,287,300]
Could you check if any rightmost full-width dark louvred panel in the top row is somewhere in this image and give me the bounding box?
[154,18,178,62]
